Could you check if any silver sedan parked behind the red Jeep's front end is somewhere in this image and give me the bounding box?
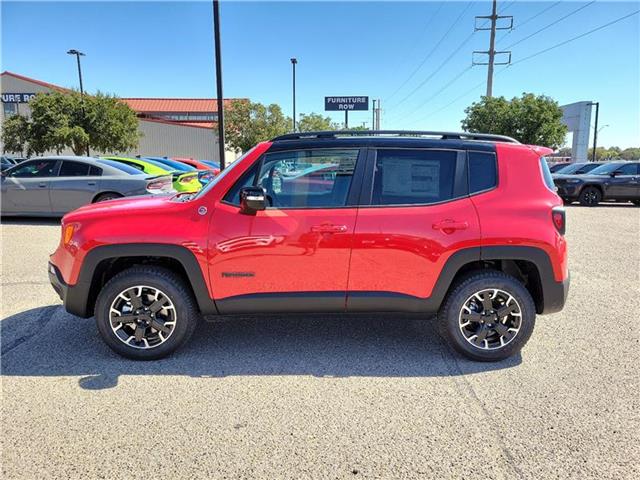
[0,157,173,217]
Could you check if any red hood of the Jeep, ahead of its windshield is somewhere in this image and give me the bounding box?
[63,193,175,222]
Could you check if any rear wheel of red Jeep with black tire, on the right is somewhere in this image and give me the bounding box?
[438,270,536,362]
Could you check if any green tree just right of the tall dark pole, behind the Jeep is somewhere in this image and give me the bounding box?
[225,100,291,152]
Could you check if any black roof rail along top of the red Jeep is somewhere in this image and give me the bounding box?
[271,130,520,143]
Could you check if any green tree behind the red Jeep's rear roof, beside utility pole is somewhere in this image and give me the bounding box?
[462,93,567,149]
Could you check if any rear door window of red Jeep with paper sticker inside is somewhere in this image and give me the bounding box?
[371,150,458,205]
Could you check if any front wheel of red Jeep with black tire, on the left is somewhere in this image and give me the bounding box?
[95,266,199,360]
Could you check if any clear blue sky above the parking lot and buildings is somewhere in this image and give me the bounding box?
[0,0,640,148]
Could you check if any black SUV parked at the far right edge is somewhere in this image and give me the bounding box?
[553,162,640,207]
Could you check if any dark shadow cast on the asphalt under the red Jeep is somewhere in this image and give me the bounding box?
[0,305,522,390]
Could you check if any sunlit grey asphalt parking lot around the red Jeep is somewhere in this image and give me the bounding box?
[0,205,640,479]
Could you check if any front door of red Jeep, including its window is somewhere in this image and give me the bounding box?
[209,149,359,313]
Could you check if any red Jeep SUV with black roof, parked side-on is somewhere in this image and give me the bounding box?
[49,131,569,361]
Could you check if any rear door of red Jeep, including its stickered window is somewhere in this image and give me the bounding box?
[347,149,480,311]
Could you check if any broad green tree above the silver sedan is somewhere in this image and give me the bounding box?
[2,92,139,155]
